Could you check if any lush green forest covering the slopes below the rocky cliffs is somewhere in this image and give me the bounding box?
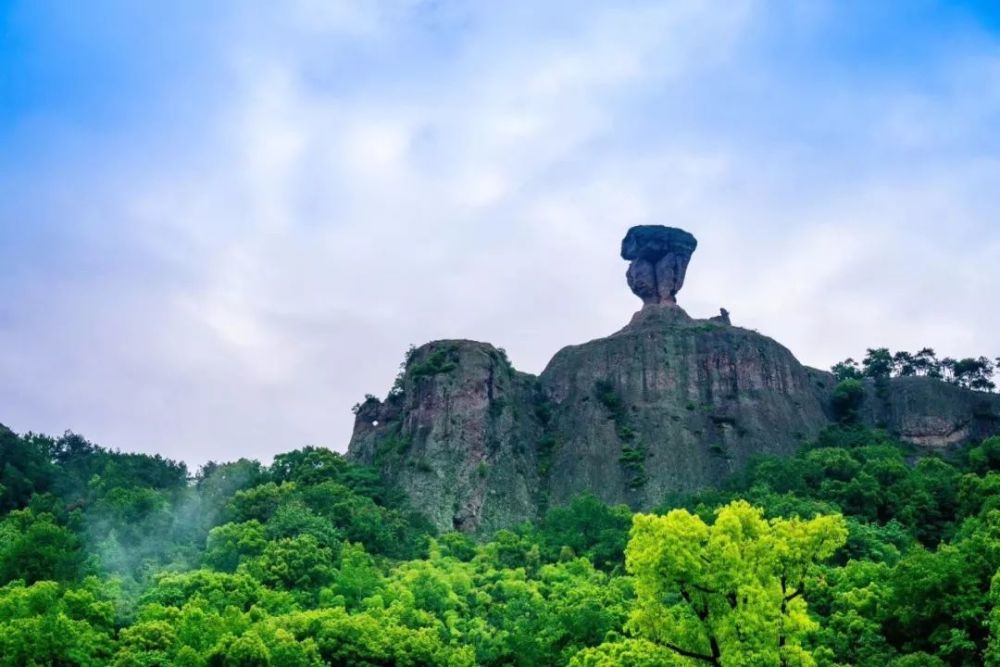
[0,422,1000,667]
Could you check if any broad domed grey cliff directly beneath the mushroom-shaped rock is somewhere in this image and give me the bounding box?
[541,306,828,507]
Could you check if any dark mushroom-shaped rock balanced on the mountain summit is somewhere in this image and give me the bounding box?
[622,225,698,306]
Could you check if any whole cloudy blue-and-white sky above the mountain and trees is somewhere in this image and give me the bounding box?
[0,0,1000,468]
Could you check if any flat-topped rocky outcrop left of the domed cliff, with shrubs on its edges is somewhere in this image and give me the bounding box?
[348,340,541,530]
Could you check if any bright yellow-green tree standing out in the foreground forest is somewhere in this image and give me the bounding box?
[626,501,847,667]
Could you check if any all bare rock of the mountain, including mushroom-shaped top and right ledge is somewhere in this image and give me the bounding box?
[348,226,1000,530]
